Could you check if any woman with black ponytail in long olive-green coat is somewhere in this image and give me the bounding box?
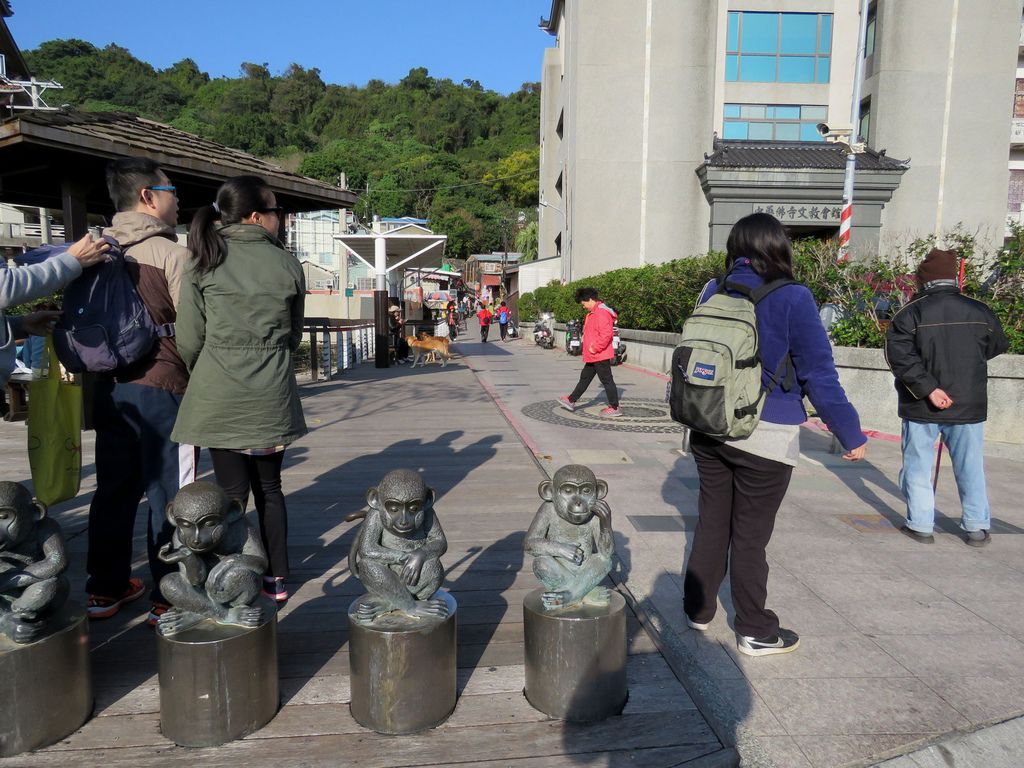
[171,176,306,601]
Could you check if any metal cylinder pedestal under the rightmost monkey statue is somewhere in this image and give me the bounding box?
[522,588,629,723]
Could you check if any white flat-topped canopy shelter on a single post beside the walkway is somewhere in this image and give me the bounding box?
[335,224,447,368]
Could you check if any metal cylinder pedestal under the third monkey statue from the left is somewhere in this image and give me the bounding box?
[348,590,457,734]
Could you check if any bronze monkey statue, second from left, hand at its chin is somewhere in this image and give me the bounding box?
[158,480,267,637]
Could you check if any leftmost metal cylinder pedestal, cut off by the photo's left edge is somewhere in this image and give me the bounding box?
[0,603,92,758]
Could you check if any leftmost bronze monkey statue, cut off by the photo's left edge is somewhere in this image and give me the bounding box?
[0,480,69,644]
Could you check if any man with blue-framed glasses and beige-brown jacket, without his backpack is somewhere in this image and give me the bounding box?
[86,158,197,624]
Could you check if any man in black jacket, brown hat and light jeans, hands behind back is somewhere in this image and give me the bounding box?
[886,248,1010,547]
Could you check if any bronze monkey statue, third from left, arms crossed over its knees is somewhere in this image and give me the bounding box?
[347,469,449,625]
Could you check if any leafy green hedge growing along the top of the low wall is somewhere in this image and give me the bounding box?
[519,226,1024,354]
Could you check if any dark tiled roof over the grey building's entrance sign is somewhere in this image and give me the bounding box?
[705,140,909,171]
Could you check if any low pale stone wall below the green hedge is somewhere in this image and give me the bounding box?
[620,330,1024,444]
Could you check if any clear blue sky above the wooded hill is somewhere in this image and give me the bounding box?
[7,0,554,93]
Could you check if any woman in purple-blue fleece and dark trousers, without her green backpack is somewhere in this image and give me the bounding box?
[683,213,867,656]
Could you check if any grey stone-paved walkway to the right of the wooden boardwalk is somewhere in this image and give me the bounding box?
[460,341,1024,768]
